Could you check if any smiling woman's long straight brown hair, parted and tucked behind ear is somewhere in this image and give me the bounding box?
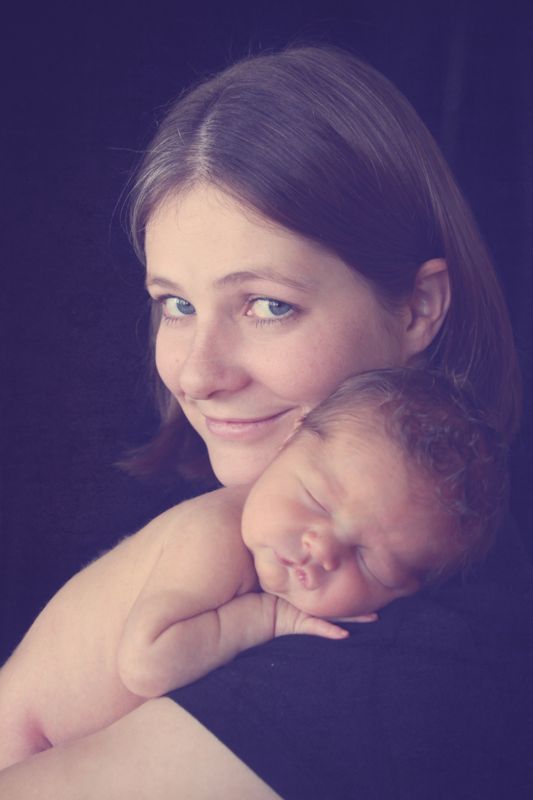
[125,46,520,484]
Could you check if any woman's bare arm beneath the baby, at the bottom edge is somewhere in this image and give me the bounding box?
[0,697,279,800]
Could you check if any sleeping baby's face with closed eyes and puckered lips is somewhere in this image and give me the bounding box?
[242,424,442,619]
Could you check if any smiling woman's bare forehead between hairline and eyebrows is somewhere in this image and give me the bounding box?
[145,184,368,290]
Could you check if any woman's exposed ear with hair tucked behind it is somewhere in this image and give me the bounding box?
[403,258,451,363]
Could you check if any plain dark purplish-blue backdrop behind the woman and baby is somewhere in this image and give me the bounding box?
[0,0,533,661]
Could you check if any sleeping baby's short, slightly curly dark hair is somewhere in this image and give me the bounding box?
[297,368,508,582]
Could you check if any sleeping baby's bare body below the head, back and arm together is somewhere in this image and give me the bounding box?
[0,487,347,768]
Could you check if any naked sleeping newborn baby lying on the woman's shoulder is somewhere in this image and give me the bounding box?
[0,369,505,768]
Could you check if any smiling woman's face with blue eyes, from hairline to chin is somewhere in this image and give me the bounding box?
[146,184,405,485]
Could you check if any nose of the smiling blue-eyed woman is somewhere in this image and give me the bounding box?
[178,330,247,400]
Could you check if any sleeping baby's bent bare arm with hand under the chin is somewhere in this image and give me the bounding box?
[118,488,343,697]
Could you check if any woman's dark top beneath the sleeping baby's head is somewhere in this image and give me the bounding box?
[170,524,533,800]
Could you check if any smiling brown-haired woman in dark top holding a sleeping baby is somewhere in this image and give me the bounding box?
[0,47,533,800]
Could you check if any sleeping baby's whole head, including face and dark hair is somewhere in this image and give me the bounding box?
[243,369,507,618]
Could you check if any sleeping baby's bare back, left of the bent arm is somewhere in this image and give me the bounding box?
[0,526,164,756]
